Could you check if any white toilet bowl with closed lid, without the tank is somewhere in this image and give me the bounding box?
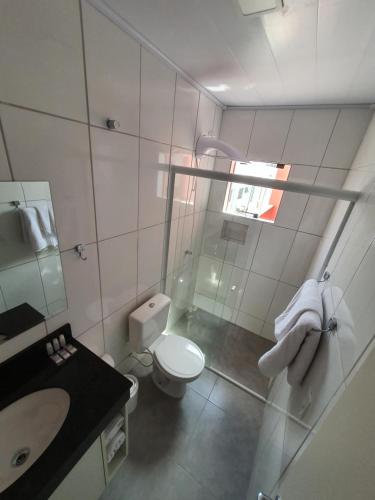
[152,335,205,398]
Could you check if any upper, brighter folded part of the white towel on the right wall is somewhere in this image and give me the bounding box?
[275,279,323,340]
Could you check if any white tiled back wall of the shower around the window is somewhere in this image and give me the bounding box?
[194,108,371,340]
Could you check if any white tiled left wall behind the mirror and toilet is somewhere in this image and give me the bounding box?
[0,0,221,363]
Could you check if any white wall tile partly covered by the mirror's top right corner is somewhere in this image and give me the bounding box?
[1,106,96,250]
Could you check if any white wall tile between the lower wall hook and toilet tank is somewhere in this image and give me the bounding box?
[99,232,137,317]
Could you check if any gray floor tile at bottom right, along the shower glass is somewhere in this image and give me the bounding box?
[178,402,257,500]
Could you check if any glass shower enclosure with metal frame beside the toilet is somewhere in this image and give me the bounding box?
[163,165,359,500]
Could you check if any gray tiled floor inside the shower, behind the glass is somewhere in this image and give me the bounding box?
[170,309,273,396]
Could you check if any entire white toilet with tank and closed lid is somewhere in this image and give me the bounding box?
[129,293,205,398]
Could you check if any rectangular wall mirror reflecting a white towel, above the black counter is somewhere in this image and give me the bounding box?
[0,182,67,338]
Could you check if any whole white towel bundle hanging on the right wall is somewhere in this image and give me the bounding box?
[258,280,323,386]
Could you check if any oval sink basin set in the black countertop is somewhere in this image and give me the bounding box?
[0,388,70,493]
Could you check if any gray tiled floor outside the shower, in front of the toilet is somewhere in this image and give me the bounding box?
[101,365,263,500]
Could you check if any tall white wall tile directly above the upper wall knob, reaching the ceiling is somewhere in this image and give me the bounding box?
[83,2,140,135]
